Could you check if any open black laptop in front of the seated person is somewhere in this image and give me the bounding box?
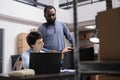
[29,52,61,74]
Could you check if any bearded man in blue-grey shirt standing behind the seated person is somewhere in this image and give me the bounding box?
[38,5,73,52]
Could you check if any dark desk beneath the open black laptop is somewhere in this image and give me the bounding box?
[0,72,75,80]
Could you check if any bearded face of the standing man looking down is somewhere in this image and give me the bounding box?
[45,8,56,24]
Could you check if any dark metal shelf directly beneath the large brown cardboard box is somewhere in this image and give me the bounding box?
[80,61,120,76]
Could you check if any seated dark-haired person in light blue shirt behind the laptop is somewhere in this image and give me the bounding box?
[22,31,71,69]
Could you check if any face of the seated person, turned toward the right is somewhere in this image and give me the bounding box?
[32,38,44,52]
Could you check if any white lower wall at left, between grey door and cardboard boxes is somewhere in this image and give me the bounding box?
[0,20,36,73]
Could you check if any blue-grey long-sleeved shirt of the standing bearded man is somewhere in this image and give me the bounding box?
[38,21,73,51]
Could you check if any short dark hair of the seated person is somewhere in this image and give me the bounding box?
[26,31,42,48]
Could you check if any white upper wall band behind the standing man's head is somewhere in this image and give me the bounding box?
[0,0,106,23]
